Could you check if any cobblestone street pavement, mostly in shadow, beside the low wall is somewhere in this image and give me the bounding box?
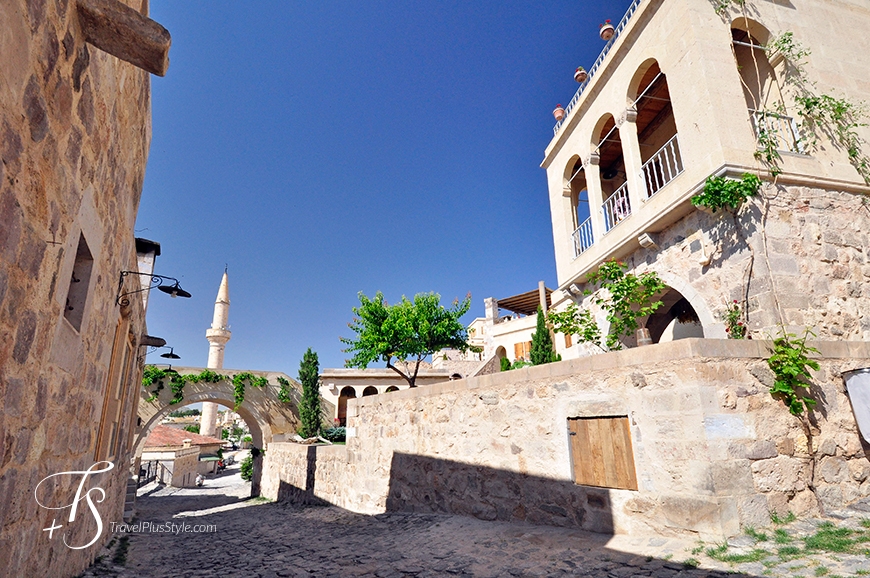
[84,470,870,578]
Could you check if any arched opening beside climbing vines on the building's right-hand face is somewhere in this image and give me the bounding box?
[731,18,803,153]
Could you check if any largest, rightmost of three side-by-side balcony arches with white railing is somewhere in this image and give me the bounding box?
[630,60,683,197]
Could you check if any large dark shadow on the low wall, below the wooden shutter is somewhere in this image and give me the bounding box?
[387,453,613,534]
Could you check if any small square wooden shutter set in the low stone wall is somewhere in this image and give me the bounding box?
[568,416,637,490]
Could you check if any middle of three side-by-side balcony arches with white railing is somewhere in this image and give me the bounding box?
[593,114,631,231]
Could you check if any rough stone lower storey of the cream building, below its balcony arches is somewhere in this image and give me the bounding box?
[627,184,870,340]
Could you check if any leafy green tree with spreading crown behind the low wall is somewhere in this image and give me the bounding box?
[341,291,472,387]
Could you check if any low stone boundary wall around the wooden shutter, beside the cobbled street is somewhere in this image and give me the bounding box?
[263,339,870,539]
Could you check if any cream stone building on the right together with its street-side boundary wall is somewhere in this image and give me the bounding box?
[263,0,870,540]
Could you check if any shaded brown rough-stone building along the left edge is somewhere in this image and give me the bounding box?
[0,0,170,576]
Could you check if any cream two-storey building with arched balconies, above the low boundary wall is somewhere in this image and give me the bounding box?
[541,0,870,344]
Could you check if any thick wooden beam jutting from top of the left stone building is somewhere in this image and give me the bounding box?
[76,0,172,76]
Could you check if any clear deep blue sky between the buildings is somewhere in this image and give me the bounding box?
[136,0,629,376]
